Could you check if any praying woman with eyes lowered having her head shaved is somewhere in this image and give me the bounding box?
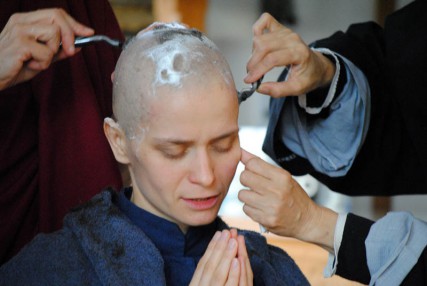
[0,24,308,285]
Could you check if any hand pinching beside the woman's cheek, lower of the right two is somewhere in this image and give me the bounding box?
[238,149,337,251]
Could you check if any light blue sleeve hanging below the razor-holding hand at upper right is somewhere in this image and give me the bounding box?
[279,51,370,177]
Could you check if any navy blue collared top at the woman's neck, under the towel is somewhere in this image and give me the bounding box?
[116,188,217,285]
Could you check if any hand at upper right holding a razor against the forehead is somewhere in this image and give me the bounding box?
[244,13,335,97]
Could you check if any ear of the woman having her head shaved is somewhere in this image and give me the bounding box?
[104,117,130,165]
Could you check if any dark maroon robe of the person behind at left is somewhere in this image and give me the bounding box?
[0,0,123,264]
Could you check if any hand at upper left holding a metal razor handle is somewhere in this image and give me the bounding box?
[0,9,94,90]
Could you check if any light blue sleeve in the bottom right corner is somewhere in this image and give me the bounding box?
[365,212,427,285]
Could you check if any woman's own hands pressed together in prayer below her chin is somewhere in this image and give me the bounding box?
[190,229,253,286]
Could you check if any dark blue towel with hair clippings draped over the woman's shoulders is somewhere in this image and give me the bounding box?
[0,190,308,286]
